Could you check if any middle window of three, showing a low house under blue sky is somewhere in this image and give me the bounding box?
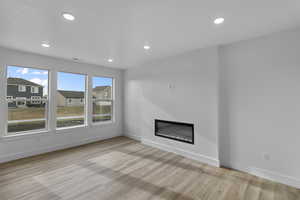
[56,72,86,128]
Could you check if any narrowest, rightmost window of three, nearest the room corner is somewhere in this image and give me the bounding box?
[92,77,113,123]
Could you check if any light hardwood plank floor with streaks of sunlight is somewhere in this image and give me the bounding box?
[0,137,300,200]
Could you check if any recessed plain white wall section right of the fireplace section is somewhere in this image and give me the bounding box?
[219,29,300,187]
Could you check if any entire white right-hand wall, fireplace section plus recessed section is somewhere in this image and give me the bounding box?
[124,28,300,188]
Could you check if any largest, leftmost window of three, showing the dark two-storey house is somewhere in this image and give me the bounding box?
[6,66,48,135]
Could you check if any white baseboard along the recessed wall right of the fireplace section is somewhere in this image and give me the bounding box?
[232,164,300,189]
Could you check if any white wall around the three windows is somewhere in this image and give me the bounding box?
[0,48,123,162]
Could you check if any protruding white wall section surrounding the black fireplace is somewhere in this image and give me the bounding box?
[124,48,218,165]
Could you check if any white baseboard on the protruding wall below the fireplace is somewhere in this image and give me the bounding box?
[141,139,220,167]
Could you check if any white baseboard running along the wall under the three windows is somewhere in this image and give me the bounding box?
[0,135,119,163]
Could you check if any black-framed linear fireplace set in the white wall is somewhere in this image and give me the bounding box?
[155,119,194,144]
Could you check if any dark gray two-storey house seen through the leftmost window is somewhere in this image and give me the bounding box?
[6,78,43,107]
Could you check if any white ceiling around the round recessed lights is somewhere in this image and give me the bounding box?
[0,0,300,68]
